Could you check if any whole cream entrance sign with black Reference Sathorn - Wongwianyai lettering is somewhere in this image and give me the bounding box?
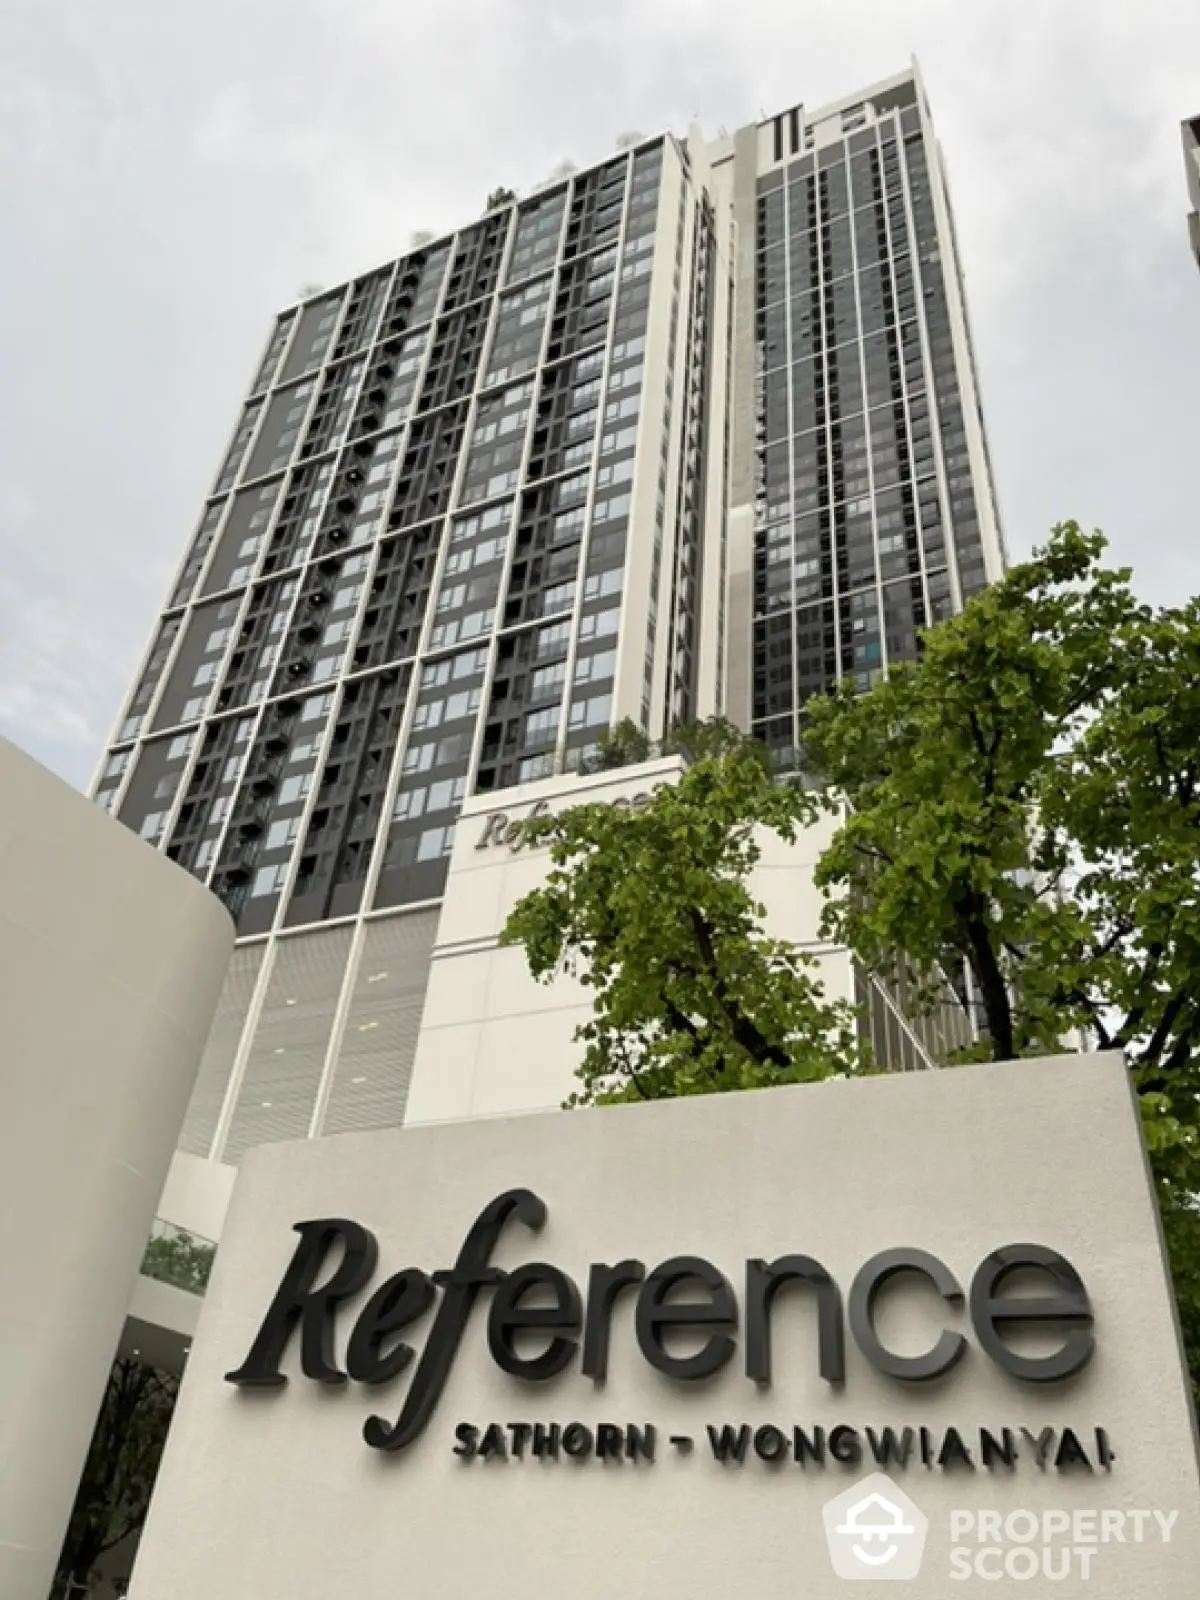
[131,1056,1200,1600]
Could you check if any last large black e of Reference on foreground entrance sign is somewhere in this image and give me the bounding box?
[971,1245,1096,1384]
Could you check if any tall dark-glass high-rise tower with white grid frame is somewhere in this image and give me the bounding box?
[94,69,1003,1162]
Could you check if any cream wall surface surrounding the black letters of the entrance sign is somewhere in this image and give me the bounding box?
[131,1056,1200,1600]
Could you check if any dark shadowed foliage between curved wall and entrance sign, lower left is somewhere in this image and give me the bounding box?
[53,1355,179,1600]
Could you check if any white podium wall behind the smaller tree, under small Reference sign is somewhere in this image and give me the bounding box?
[405,757,853,1126]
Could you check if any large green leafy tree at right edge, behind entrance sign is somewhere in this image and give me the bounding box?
[806,523,1200,1374]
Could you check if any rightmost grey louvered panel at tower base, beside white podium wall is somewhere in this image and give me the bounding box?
[322,910,437,1133]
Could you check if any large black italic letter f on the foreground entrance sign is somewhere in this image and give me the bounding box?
[363,1189,546,1450]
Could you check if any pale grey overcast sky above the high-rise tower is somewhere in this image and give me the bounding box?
[0,0,1200,786]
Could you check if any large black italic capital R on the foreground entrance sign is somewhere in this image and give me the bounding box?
[226,1218,379,1389]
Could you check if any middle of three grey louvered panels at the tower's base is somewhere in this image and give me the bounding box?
[221,928,350,1163]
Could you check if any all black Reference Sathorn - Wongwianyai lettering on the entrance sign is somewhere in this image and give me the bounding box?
[226,1189,1112,1469]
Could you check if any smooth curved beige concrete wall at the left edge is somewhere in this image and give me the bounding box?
[0,739,234,1600]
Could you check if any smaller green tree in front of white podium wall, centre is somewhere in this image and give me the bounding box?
[502,733,858,1104]
